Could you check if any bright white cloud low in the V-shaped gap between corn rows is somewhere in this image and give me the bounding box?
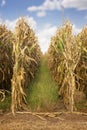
[37,24,57,53]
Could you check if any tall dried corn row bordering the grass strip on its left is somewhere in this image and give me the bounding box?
[12,18,40,113]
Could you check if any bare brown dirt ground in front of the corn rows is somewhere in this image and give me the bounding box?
[0,113,87,130]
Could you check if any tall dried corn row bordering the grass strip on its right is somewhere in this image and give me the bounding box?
[48,22,81,112]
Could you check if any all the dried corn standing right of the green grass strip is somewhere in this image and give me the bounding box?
[48,22,87,112]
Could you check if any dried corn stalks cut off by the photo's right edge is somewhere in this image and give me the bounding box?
[75,27,87,96]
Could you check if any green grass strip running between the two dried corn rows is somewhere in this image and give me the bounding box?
[27,58,58,110]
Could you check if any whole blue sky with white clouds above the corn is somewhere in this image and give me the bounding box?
[0,0,87,52]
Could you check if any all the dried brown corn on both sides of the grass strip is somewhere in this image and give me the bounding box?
[0,18,87,114]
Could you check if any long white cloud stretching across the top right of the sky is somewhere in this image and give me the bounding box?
[27,0,87,17]
